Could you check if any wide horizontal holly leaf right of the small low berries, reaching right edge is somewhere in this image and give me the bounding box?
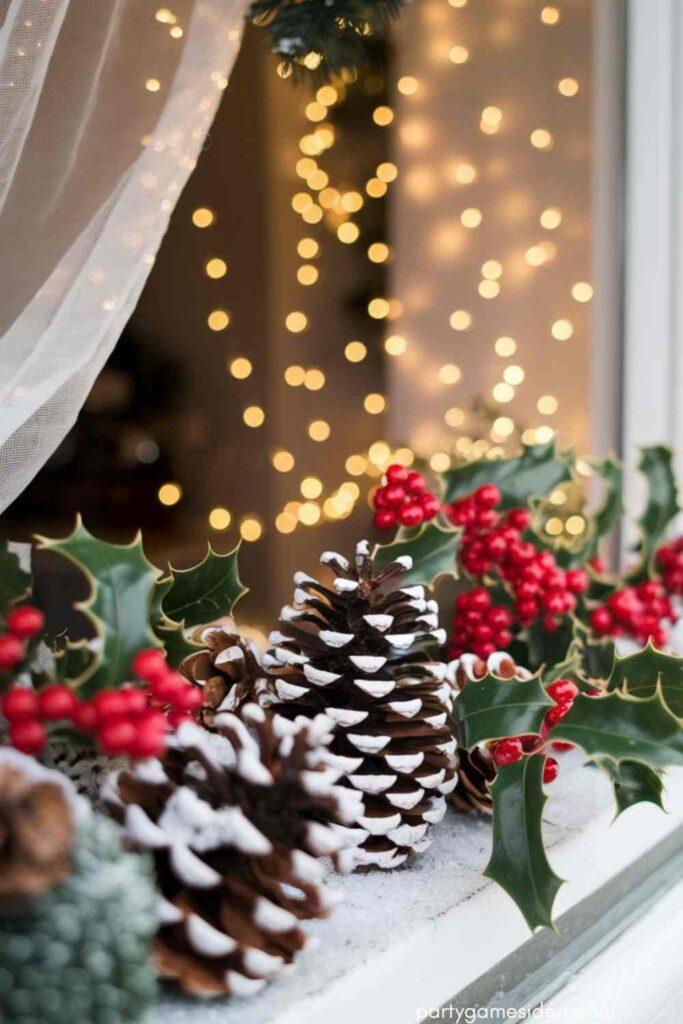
[553,688,683,768]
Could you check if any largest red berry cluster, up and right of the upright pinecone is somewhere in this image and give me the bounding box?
[447,483,589,633]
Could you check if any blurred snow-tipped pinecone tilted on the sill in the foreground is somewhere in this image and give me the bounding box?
[106,705,359,996]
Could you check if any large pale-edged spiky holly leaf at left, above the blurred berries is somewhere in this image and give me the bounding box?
[36,516,161,696]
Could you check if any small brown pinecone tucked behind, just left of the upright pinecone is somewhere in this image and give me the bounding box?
[180,626,263,729]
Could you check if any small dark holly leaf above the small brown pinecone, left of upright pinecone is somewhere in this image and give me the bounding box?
[162,544,247,629]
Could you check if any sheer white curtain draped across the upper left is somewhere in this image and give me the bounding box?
[0,0,247,512]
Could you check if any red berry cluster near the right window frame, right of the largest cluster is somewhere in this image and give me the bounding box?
[591,580,676,647]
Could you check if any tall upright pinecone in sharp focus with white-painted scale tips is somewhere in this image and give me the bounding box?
[255,541,458,868]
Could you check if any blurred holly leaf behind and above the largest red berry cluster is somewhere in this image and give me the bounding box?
[441,440,572,509]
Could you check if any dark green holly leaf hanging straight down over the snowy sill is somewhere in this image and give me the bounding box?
[483,757,563,931]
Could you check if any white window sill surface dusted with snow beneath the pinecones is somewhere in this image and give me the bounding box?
[145,754,683,1024]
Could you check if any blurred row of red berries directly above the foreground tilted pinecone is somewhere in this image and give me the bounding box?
[0,650,202,759]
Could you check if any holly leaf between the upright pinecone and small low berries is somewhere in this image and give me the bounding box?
[452,675,553,750]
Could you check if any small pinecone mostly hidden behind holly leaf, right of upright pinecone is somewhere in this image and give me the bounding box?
[449,651,531,814]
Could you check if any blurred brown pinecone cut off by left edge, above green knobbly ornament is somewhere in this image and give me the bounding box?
[0,748,75,902]
